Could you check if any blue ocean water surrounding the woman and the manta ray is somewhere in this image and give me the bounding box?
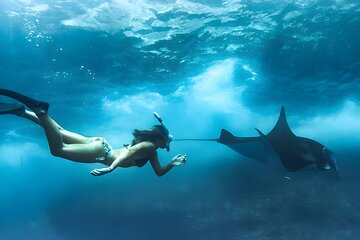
[0,0,360,240]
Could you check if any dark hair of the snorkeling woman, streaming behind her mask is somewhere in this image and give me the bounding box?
[131,125,169,145]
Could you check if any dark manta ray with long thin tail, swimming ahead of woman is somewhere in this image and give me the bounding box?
[174,107,337,173]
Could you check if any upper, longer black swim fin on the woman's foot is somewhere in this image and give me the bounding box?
[0,88,49,114]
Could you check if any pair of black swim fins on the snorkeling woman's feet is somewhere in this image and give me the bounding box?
[0,88,49,115]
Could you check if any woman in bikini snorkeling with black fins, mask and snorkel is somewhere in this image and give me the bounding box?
[0,88,186,176]
